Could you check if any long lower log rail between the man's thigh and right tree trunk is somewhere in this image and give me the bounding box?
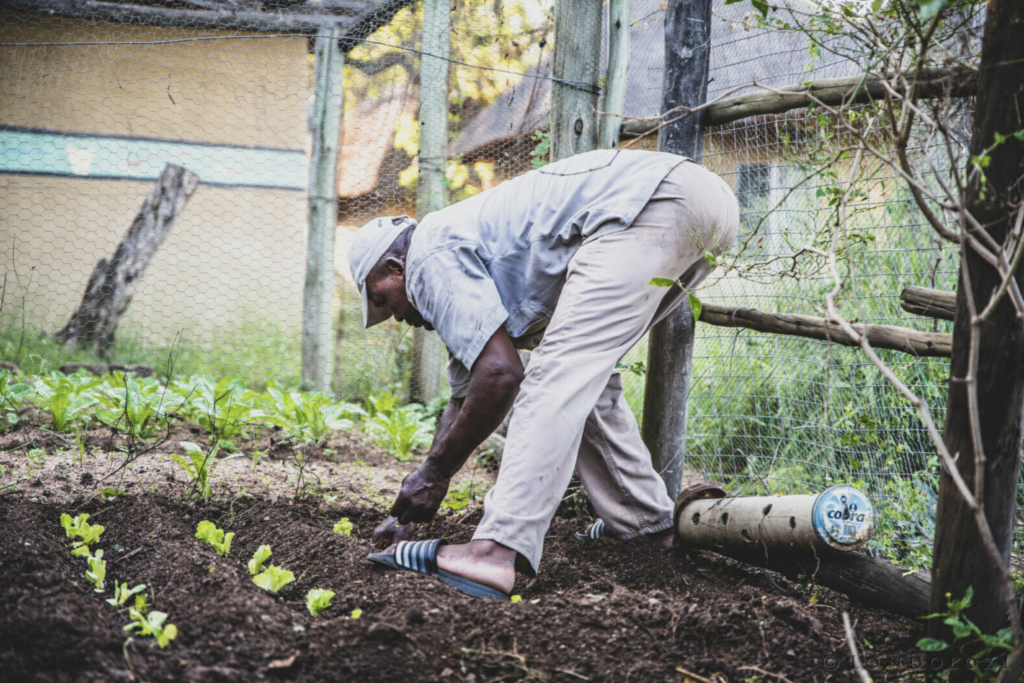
[697,303,953,358]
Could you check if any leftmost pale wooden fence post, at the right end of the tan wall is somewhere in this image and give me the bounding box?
[302,28,345,393]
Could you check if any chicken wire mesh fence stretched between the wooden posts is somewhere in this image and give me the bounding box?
[0,0,991,552]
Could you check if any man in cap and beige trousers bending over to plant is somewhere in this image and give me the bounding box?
[350,150,739,598]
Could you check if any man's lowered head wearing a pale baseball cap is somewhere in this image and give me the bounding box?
[348,216,433,330]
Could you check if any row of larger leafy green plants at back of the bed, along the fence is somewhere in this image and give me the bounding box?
[0,370,433,462]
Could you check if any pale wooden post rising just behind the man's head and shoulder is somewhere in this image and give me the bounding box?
[411,0,452,402]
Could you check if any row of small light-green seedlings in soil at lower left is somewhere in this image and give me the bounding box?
[60,513,178,648]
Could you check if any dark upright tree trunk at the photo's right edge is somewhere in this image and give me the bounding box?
[929,0,1024,655]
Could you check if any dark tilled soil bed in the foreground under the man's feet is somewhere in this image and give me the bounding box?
[0,494,922,683]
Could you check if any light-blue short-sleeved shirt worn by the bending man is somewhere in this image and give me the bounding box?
[406,150,685,397]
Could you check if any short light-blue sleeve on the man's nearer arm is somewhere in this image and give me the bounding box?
[410,245,509,374]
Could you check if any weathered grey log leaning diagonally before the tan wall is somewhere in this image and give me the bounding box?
[56,164,199,358]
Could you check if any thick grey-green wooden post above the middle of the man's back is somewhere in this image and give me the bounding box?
[551,0,602,161]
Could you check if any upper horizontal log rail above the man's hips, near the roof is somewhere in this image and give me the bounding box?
[622,69,977,139]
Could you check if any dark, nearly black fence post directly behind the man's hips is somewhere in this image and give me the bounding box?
[643,0,711,499]
